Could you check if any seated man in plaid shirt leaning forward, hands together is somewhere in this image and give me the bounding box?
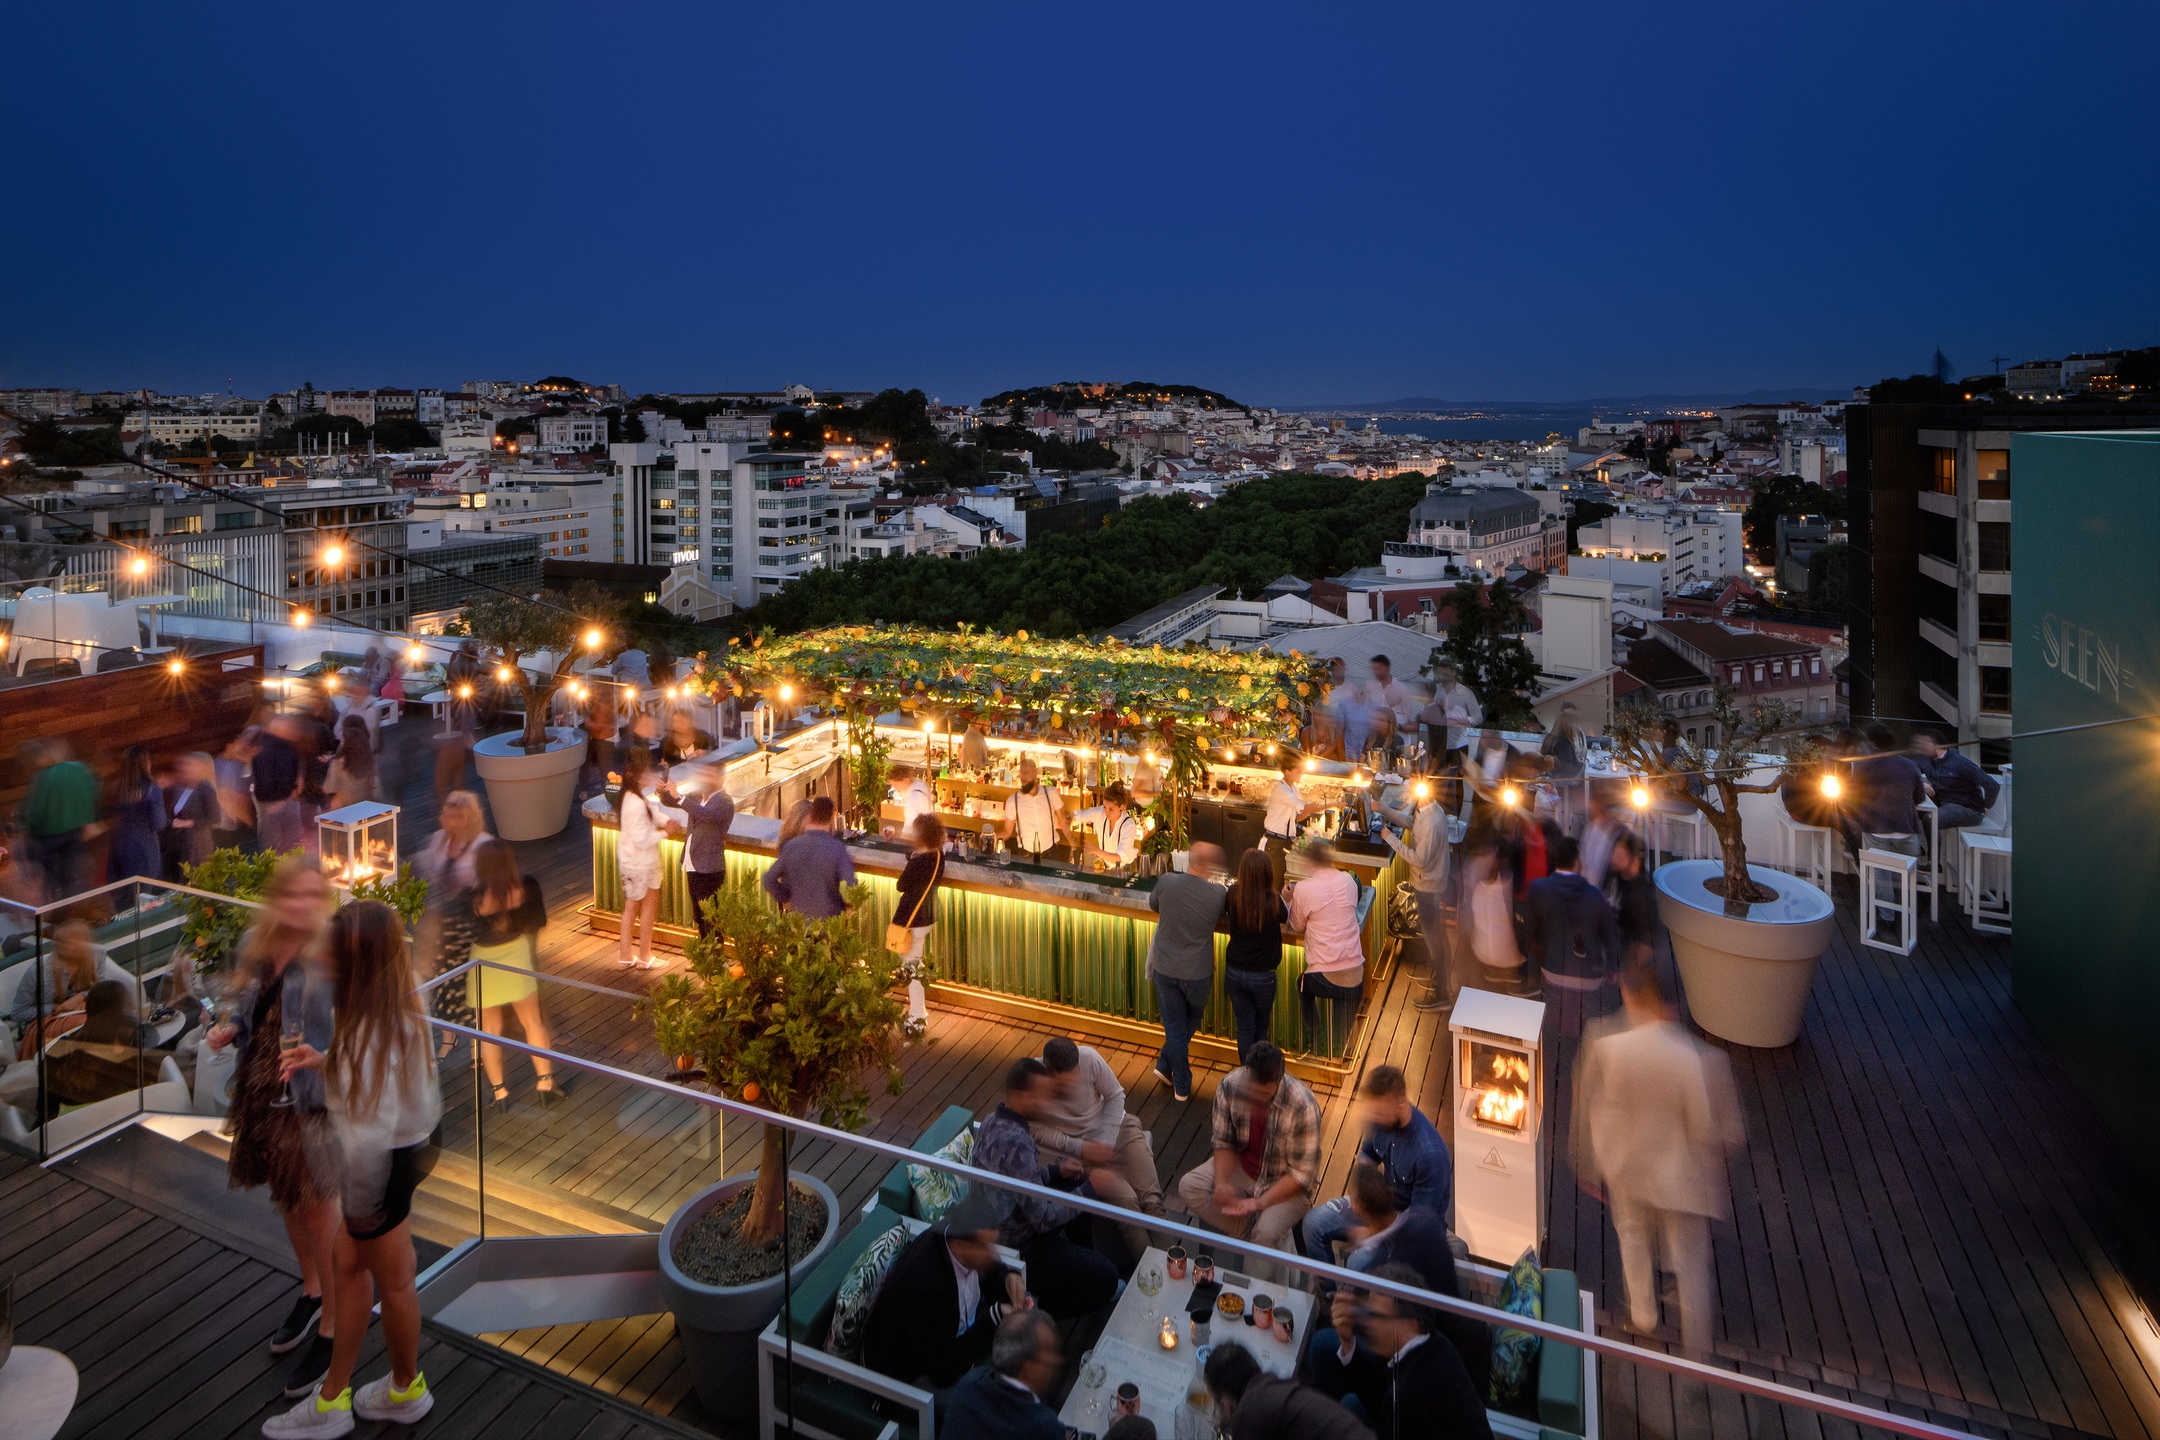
[1177,1041,1320,1250]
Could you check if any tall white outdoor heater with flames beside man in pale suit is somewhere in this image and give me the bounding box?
[1447,987,1547,1267]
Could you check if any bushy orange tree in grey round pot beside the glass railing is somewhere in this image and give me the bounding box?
[646,874,903,1416]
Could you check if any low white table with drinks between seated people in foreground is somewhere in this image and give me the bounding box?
[1058,1246,1313,1440]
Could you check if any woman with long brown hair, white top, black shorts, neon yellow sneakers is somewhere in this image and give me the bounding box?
[264,900,443,1440]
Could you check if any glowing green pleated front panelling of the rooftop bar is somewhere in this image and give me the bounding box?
[592,825,1398,1058]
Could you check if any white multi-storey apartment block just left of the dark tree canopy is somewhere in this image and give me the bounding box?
[609,438,840,609]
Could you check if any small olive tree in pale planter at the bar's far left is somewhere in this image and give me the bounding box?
[462,594,611,840]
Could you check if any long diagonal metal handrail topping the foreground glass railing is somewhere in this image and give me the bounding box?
[428,993,1970,1440]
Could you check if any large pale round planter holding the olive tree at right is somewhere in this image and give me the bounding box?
[1655,859,1834,1049]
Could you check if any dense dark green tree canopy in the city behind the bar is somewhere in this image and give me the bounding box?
[743,475,1426,637]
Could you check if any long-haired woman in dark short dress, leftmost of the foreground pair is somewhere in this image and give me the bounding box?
[203,855,339,1395]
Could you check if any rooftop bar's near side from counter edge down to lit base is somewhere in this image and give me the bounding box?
[585,794,1398,1077]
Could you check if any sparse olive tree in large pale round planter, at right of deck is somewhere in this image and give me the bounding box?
[1611,684,1832,1047]
